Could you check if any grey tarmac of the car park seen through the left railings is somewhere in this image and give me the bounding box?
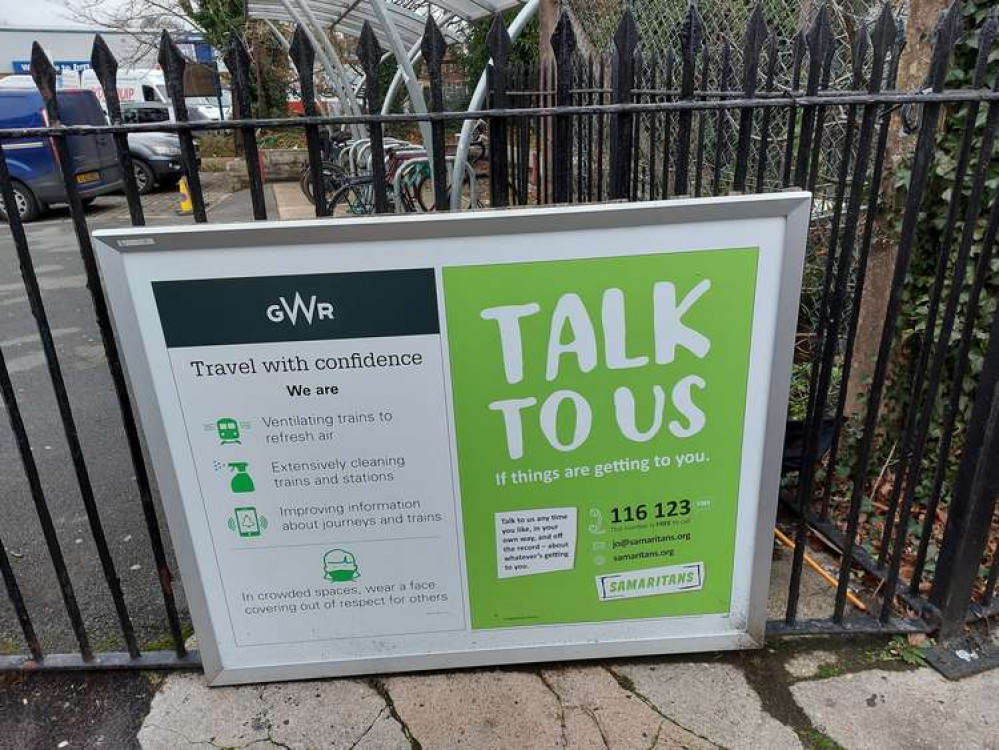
[0,175,277,654]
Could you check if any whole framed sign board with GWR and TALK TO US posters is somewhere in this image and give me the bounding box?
[95,193,810,684]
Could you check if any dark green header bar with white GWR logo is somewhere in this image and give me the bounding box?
[153,268,440,347]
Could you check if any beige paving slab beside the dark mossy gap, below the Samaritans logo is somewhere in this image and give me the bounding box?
[612,661,802,750]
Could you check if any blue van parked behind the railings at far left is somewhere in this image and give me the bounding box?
[0,88,122,221]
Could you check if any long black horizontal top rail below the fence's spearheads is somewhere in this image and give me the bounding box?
[0,89,999,140]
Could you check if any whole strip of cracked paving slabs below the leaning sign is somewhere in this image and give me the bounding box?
[131,639,999,750]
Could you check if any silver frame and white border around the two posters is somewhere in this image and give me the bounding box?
[94,192,811,685]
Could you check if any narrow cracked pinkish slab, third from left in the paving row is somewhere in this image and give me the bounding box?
[541,666,716,750]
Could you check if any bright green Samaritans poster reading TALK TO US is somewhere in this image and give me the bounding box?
[444,248,758,628]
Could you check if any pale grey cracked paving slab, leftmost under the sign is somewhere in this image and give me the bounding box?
[138,674,411,750]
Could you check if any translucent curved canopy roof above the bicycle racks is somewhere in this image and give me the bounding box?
[247,0,521,47]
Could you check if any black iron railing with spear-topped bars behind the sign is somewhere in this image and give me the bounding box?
[0,0,999,669]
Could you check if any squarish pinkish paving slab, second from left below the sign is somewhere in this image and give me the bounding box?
[382,670,566,750]
